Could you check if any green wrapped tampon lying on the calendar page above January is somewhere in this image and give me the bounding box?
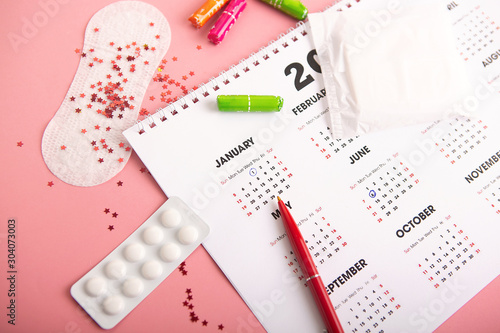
[217,95,283,112]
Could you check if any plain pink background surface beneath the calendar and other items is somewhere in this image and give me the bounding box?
[0,0,500,333]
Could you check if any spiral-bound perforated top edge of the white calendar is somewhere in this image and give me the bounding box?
[136,0,361,135]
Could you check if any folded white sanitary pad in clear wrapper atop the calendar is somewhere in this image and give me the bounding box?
[309,1,474,139]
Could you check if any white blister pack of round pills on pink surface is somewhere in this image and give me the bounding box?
[71,197,210,329]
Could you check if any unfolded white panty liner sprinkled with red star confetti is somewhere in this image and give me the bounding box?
[42,1,171,186]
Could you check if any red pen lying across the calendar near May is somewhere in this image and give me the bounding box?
[278,197,344,333]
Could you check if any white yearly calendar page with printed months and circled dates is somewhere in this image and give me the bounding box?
[124,1,500,333]
